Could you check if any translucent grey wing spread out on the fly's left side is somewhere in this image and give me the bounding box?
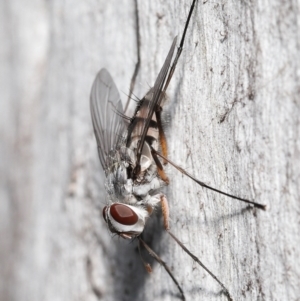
[90,69,126,170]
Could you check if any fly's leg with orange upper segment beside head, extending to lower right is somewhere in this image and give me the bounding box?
[160,195,233,301]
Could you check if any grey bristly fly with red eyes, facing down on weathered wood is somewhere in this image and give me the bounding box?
[90,0,265,300]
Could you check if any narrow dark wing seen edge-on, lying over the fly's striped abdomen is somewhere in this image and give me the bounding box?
[136,37,177,166]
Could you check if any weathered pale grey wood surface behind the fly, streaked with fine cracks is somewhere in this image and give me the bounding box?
[0,0,300,301]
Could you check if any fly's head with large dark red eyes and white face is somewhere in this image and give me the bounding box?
[102,203,149,239]
